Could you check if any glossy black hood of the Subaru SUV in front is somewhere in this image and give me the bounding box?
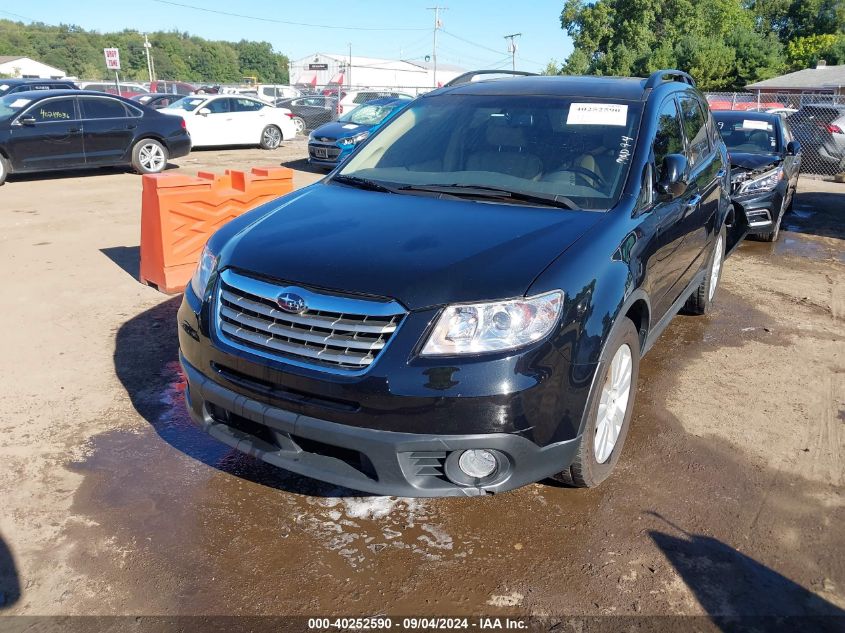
[220,183,603,310]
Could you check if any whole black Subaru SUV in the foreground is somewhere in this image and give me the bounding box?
[178,70,745,496]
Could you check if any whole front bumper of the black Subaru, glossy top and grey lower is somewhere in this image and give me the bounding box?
[178,278,595,496]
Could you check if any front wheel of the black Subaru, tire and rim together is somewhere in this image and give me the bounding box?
[554,317,640,488]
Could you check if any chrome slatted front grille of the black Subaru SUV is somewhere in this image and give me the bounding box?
[214,270,406,370]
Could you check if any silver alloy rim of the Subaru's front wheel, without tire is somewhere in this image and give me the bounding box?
[593,345,634,464]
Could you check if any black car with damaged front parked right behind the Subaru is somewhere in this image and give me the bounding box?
[713,111,801,242]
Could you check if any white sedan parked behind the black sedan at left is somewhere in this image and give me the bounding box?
[159,95,296,149]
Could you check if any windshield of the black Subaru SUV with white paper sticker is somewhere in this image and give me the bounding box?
[339,94,641,210]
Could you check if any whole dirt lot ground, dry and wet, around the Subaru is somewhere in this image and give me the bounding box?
[0,142,845,615]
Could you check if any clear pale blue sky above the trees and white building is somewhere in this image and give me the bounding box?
[0,0,572,71]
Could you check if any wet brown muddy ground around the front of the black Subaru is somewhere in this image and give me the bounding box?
[62,284,845,615]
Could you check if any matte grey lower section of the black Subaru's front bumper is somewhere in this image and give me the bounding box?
[179,354,579,497]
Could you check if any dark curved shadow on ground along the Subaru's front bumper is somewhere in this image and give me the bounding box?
[112,296,366,497]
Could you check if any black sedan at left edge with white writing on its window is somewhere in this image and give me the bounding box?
[0,90,191,184]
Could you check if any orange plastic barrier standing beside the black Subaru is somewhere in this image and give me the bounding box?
[141,167,293,293]
